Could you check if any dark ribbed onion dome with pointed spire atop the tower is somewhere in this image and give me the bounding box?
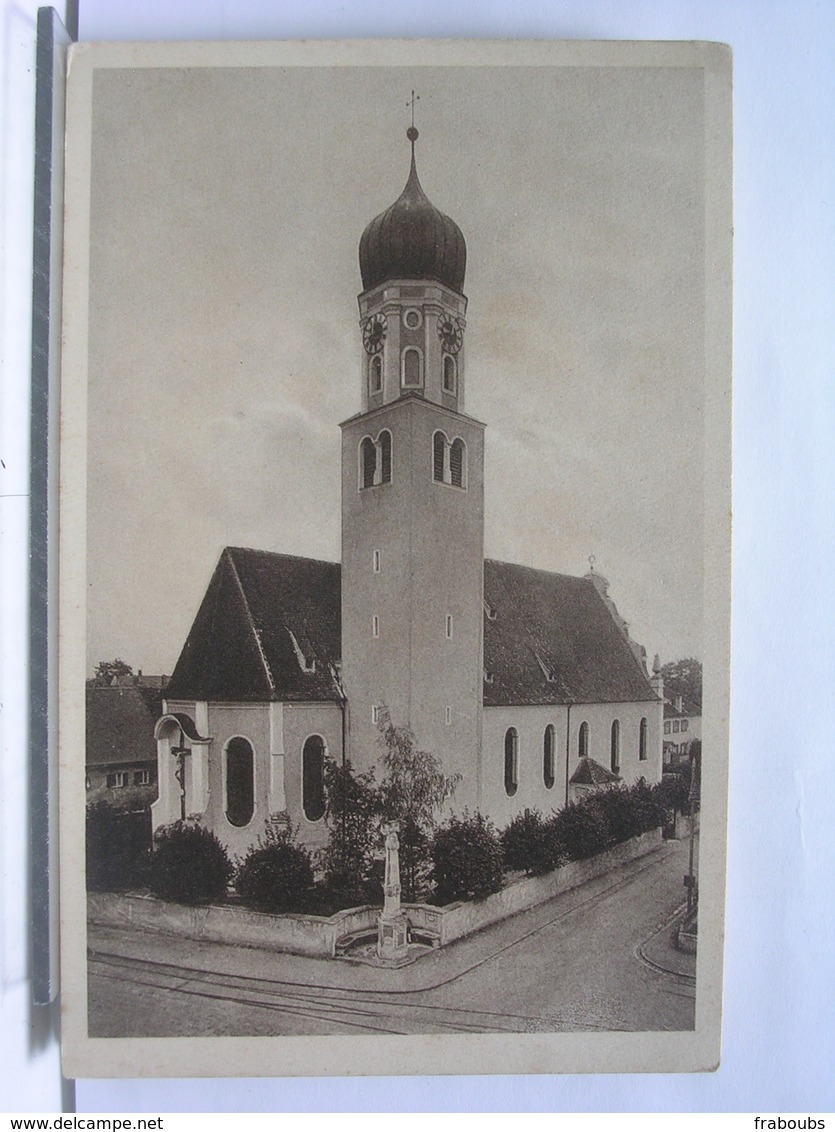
[360,127,467,292]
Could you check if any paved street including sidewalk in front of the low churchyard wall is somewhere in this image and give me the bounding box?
[88,843,695,1037]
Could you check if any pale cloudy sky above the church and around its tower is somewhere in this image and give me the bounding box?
[87,57,705,674]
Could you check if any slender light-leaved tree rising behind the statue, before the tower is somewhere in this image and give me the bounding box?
[378,712,460,902]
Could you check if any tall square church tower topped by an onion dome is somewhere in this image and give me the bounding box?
[342,126,484,811]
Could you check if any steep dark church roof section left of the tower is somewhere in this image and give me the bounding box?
[165,547,341,703]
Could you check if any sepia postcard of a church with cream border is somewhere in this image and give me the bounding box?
[60,41,731,1077]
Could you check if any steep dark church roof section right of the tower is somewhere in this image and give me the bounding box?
[484,559,657,706]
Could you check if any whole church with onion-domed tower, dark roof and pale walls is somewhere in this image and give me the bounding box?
[153,127,663,855]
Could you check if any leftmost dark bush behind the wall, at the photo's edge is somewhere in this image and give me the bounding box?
[86,801,150,892]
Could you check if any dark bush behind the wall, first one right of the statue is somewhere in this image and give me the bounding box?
[432,814,503,903]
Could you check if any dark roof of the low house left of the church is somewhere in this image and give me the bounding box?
[86,684,162,766]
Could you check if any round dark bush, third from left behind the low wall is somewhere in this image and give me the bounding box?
[235,830,313,912]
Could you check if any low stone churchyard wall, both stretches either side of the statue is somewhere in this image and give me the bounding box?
[87,830,662,959]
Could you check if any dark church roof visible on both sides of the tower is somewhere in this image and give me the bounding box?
[165,547,656,706]
